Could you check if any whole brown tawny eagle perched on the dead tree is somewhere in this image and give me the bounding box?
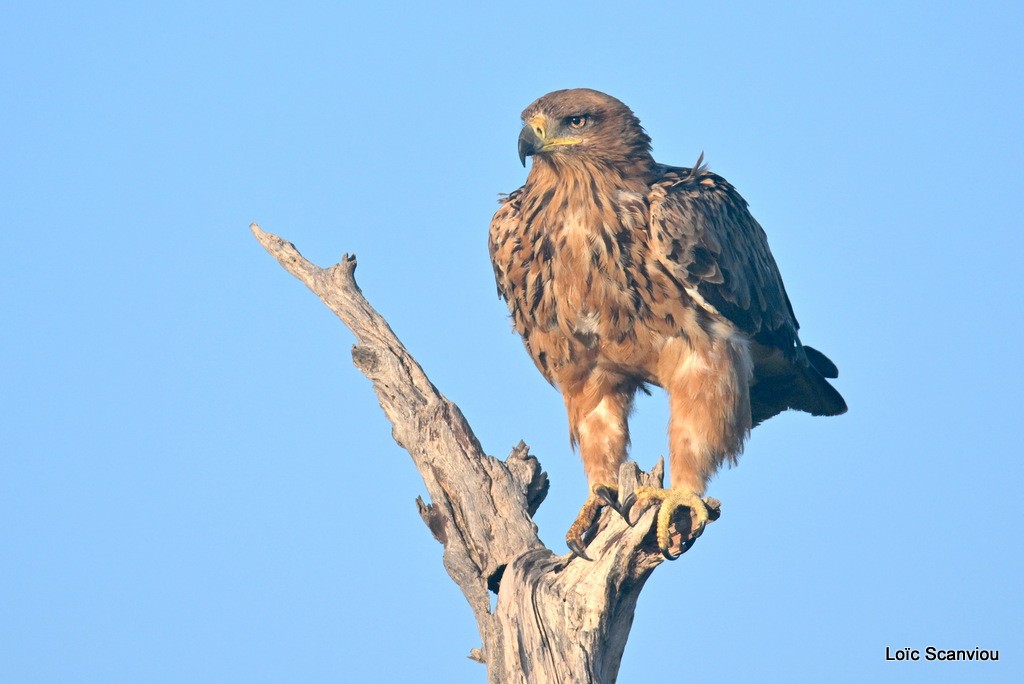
[489,89,847,557]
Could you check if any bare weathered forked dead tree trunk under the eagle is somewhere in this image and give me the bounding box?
[250,223,717,684]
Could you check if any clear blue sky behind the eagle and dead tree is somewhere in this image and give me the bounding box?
[0,2,1024,684]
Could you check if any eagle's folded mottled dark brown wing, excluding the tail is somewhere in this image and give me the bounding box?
[650,163,807,364]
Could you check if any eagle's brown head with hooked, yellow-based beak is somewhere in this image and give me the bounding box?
[519,88,653,166]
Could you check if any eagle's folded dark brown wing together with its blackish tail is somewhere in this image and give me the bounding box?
[651,160,847,417]
